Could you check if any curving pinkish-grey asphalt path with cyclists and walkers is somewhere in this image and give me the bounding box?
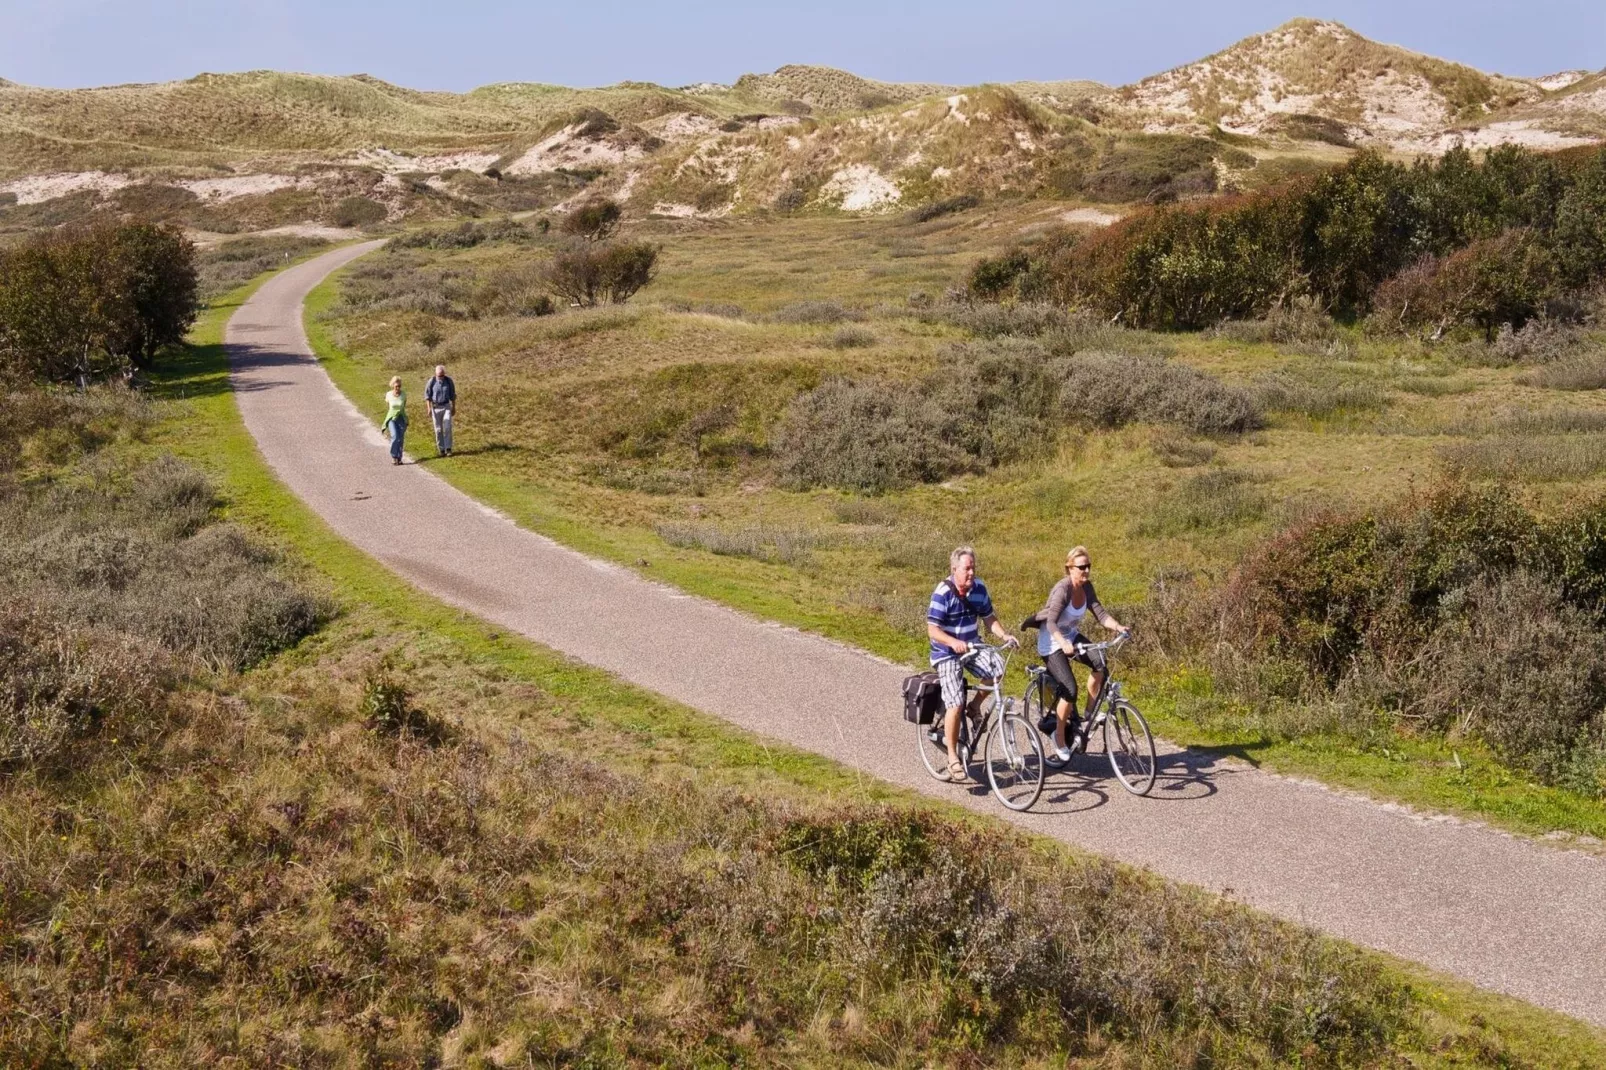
[226,243,1606,1027]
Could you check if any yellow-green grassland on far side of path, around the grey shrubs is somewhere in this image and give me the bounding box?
[308,206,1606,837]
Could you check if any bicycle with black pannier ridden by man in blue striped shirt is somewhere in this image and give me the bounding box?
[915,643,1047,810]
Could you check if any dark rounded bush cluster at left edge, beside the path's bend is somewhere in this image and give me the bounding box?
[0,223,199,384]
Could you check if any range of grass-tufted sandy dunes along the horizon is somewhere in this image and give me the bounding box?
[0,19,1606,233]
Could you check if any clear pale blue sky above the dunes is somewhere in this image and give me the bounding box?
[0,0,1606,90]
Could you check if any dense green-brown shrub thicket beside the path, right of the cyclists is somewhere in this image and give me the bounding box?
[1160,484,1606,797]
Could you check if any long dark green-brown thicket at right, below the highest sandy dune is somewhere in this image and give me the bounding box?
[972,146,1606,329]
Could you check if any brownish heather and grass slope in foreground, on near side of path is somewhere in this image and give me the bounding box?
[12,287,1595,1067]
